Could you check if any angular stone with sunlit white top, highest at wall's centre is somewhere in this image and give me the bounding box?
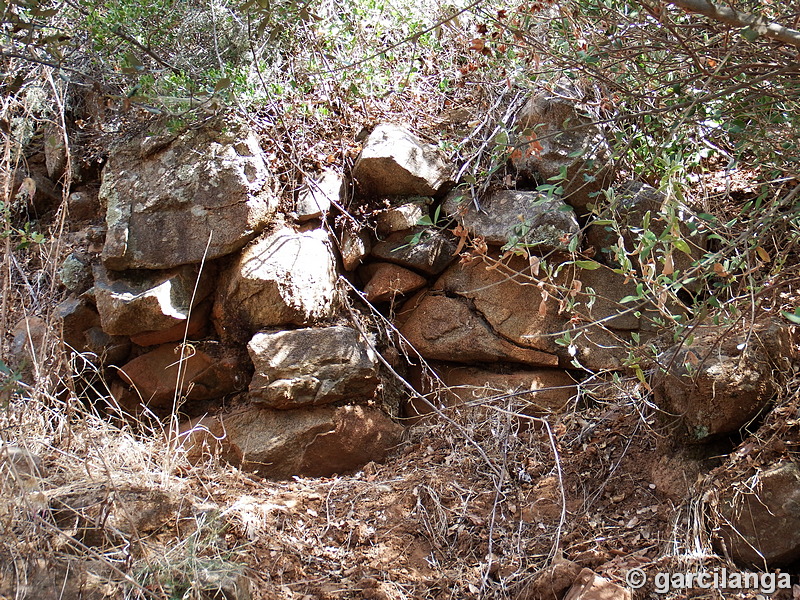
[353,123,453,196]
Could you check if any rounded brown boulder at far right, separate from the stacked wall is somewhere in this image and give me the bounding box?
[653,322,796,442]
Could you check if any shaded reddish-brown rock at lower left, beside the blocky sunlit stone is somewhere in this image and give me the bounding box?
[111,344,247,409]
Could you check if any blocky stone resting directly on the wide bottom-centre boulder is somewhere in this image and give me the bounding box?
[247,327,378,409]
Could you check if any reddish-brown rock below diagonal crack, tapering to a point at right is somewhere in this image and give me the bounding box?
[400,294,558,367]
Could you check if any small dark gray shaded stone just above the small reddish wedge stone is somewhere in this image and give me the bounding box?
[372,227,456,275]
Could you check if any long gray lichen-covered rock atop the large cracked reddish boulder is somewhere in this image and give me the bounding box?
[442,190,580,251]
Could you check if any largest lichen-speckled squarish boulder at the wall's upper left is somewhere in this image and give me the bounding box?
[100,122,278,270]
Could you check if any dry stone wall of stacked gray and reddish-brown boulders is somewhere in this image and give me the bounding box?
[43,79,800,540]
